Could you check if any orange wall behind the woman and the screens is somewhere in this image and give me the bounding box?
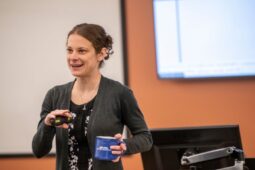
[0,0,255,170]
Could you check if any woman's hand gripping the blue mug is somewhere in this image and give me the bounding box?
[111,133,127,162]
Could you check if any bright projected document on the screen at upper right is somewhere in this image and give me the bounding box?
[153,0,255,78]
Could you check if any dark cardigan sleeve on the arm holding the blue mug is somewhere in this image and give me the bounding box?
[121,89,153,154]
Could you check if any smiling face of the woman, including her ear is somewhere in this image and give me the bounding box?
[67,34,105,77]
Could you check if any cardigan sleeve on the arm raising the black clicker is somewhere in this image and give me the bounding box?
[32,89,56,158]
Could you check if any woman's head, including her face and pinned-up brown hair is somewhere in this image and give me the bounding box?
[67,24,112,76]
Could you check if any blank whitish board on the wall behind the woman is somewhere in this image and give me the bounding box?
[0,0,124,154]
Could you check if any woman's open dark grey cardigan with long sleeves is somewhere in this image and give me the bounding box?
[32,76,152,170]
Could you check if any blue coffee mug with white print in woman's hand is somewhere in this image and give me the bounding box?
[95,136,122,161]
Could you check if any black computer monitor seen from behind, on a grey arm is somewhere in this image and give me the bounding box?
[141,125,242,170]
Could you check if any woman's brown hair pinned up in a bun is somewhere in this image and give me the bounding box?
[67,23,113,67]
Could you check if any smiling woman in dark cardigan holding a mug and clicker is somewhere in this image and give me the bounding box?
[32,23,152,170]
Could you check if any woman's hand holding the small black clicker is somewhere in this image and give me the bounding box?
[44,110,72,129]
